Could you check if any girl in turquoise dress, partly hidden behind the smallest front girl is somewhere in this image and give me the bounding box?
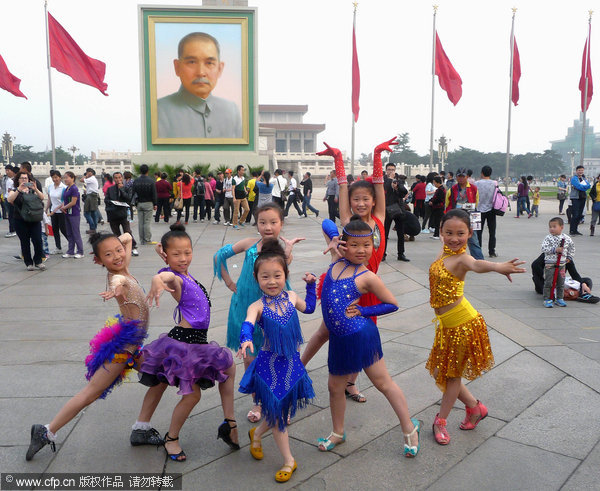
[213,203,304,423]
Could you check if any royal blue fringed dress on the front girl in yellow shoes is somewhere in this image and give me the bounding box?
[238,291,315,431]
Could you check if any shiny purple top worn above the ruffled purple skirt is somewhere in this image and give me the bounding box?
[159,268,210,329]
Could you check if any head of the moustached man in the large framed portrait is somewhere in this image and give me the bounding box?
[173,38,224,99]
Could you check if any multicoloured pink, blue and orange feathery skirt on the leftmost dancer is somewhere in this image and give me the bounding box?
[85,315,147,399]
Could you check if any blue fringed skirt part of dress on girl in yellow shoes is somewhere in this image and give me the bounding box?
[239,350,315,431]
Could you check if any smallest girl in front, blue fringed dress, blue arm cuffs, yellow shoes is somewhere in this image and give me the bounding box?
[238,240,317,482]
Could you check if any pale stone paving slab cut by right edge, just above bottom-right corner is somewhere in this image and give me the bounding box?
[498,377,600,460]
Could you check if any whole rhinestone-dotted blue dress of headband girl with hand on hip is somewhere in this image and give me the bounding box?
[321,259,383,375]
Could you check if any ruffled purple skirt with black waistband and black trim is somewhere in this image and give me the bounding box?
[139,326,233,395]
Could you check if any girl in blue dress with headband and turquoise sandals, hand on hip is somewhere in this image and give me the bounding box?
[318,217,422,457]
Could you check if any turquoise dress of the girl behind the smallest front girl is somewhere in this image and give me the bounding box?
[214,239,292,351]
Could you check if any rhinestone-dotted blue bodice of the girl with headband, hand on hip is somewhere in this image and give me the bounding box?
[321,258,372,336]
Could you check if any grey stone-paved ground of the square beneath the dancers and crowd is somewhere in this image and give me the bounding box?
[0,194,600,490]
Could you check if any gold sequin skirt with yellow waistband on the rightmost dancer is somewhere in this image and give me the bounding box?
[425,297,494,391]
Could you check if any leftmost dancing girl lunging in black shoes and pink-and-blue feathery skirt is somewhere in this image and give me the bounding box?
[25,233,149,460]
